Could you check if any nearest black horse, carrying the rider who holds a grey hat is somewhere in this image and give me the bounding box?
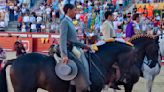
[0,41,138,92]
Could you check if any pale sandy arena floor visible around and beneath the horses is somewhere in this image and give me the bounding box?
[4,52,164,92]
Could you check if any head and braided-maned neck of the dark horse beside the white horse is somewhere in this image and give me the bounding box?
[129,34,160,68]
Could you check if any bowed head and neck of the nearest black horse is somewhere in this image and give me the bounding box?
[95,41,138,82]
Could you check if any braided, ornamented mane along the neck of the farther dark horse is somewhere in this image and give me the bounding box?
[129,34,155,42]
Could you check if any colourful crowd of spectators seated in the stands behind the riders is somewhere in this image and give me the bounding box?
[3,0,164,37]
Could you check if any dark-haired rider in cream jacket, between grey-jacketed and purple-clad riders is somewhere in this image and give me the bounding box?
[100,11,120,90]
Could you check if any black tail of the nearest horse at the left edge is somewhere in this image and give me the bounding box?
[0,60,14,92]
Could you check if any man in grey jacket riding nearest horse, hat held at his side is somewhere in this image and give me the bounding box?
[60,4,91,92]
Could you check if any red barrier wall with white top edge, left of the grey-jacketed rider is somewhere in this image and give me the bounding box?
[0,32,59,52]
